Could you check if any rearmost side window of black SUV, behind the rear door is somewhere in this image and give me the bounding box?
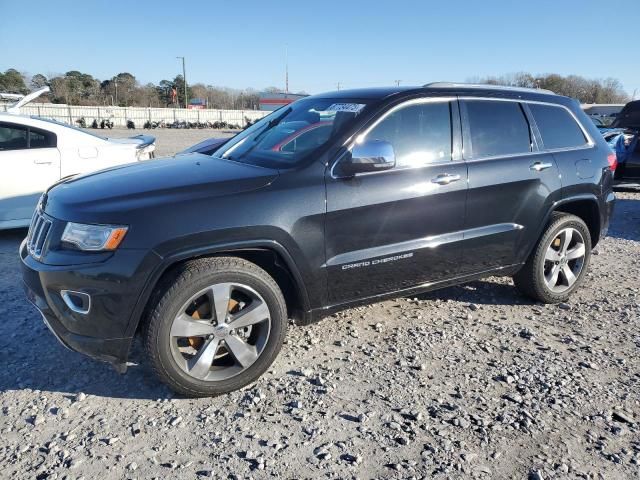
[529,103,587,148]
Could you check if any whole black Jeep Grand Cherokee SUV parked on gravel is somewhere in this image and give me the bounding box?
[20,83,615,396]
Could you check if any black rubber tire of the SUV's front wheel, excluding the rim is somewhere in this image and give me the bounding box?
[144,257,288,397]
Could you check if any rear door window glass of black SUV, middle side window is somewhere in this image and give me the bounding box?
[465,100,531,157]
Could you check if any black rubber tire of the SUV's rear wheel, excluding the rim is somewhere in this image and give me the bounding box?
[513,212,591,303]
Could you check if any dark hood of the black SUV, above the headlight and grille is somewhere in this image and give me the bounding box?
[45,153,278,223]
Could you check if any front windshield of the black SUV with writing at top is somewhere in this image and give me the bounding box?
[213,98,366,168]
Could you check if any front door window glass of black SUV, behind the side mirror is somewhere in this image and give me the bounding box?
[367,102,451,167]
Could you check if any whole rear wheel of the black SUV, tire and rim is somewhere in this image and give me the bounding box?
[513,212,591,303]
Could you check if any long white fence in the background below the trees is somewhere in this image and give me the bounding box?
[1,103,270,128]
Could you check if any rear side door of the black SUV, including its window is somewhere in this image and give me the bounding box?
[461,98,561,272]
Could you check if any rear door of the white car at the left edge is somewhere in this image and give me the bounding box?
[0,122,60,223]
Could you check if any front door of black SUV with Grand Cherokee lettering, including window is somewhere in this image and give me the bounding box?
[325,99,467,305]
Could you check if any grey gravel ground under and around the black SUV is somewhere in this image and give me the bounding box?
[0,149,640,479]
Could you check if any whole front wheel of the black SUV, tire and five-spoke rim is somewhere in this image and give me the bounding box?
[145,257,287,396]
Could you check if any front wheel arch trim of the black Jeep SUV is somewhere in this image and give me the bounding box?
[127,240,310,336]
